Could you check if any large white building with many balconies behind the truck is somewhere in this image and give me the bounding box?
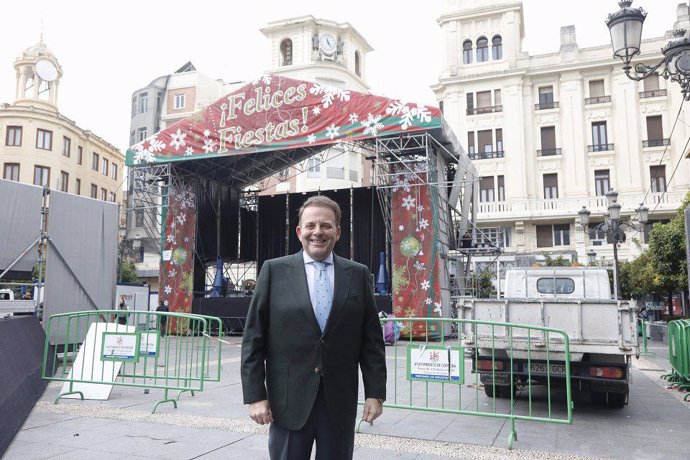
[432,0,690,276]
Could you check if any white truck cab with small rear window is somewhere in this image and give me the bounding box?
[504,267,611,300]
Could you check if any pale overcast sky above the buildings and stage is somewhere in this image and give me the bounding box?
[0,0,678,152]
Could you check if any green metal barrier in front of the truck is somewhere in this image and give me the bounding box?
[357,318,573,449]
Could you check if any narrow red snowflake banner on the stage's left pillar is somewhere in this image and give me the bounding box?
[158,180,196,332]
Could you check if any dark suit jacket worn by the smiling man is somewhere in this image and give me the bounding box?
[241,252,386,430]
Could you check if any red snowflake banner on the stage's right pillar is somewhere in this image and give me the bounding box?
[391,162,442,338]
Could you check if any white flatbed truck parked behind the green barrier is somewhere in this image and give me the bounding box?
[456,267,639,408]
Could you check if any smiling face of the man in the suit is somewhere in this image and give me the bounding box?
[297,206,340,261]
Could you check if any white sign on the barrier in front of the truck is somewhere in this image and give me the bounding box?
[407,344,465,384]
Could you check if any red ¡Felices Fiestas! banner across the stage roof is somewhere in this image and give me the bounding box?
[126,75,442,166]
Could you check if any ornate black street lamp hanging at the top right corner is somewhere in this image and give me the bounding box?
[606,0,690,101]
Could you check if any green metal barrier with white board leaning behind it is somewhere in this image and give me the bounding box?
[42,310,223,413]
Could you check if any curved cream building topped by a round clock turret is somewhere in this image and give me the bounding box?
[0,41,125,203]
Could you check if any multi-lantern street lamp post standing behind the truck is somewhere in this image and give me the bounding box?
[577,190,649,299]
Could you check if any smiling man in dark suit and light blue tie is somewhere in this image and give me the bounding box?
[242,196,386,460]
